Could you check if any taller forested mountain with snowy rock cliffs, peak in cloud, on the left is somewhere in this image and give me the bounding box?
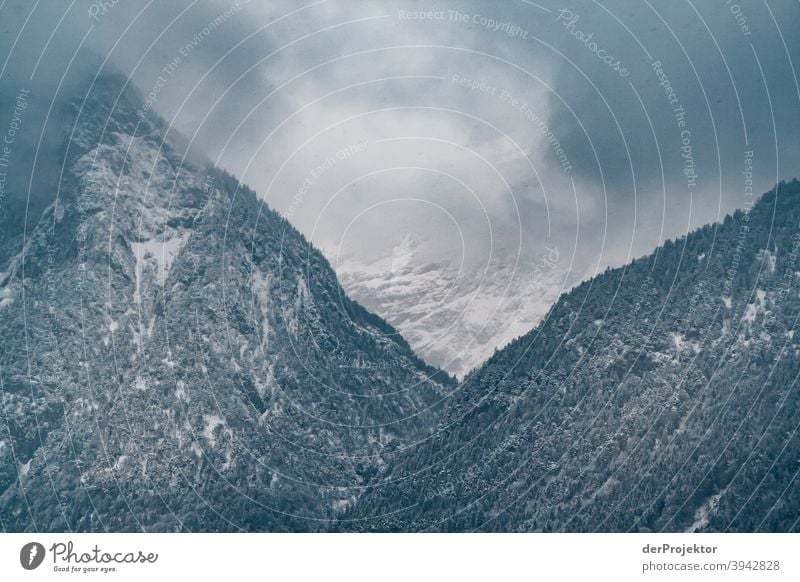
[0,75,452,531]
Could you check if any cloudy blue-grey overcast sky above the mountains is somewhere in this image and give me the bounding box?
[0,0,800,296]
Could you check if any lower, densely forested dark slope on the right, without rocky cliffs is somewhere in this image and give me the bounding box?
[342,180,800,532]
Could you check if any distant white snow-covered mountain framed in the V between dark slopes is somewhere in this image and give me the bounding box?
[336,234,571,378]
